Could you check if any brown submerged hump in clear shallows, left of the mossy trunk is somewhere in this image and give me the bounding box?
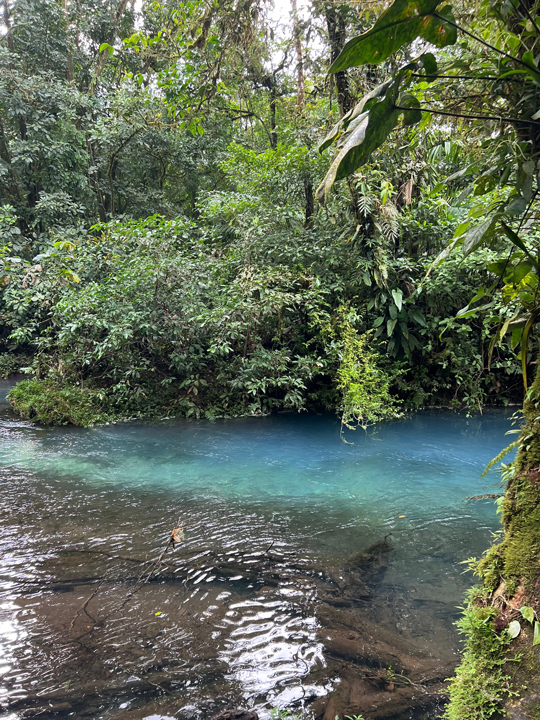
[304,538,455,720]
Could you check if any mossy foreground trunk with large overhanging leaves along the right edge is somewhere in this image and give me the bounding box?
[312,0,540,720]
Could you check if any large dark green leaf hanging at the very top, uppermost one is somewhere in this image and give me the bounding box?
[329,0,457,73]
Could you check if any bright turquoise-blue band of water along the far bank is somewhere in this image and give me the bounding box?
[0,404,510,506]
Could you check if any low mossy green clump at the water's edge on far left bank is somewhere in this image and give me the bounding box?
[8,380,110,427]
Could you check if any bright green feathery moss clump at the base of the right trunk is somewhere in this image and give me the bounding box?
[443,588,515,720]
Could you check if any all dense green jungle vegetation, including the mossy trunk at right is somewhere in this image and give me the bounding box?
[0,0,540,720]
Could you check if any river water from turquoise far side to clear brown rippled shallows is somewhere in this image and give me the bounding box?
[0,380,510,718]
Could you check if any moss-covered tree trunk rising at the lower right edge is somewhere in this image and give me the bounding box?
[445,366,540,720]
